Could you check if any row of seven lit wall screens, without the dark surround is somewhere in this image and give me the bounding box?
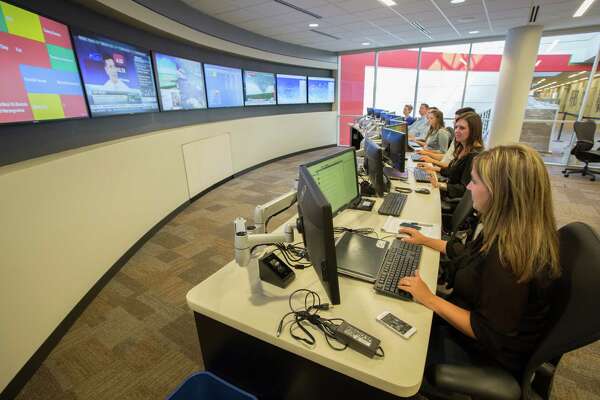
[0,1,335,124]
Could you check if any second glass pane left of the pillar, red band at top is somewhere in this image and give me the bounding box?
[417,44,469,124]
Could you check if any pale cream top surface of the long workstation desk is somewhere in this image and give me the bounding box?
[187,161,441,396]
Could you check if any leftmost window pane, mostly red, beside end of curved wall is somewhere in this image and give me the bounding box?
[339,52,375,145]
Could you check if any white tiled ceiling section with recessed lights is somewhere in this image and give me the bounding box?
[182,0,600,51]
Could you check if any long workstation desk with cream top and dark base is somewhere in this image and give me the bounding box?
[187,161,441,399]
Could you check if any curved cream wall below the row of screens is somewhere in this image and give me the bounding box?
[0,112,336,391]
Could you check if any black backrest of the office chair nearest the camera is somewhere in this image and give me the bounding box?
[522,222,600,398]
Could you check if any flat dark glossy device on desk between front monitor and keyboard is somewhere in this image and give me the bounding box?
[335,232,390,283]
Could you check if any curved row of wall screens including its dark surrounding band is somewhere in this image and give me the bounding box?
[0,0,336,165]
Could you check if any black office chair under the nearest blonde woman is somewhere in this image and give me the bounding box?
[425,222,600,400]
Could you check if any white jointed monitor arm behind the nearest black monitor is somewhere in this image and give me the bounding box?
[233,190,297,267]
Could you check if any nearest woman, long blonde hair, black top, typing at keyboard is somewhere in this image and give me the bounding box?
[398,145,561,378]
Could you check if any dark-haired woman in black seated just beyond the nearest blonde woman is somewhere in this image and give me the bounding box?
[417,112,483,199]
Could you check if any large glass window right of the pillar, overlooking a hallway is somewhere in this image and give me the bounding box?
[521,33,600,163]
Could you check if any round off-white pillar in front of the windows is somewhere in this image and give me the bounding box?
[488,25,543,147]
